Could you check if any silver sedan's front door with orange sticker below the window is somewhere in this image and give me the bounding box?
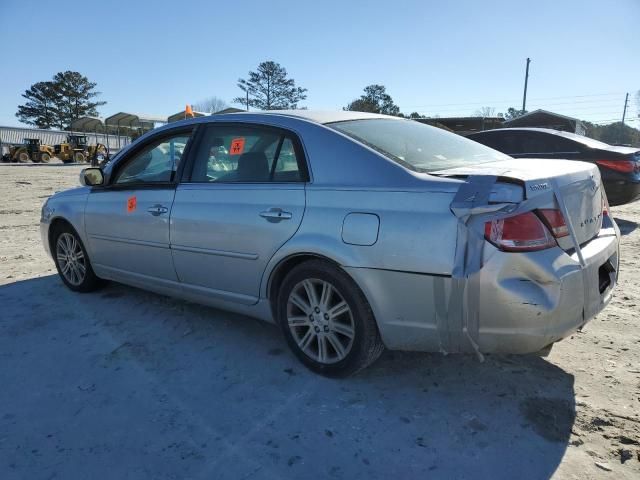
[85,132,194,282]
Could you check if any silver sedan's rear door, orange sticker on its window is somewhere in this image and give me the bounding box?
[171,123,307,304]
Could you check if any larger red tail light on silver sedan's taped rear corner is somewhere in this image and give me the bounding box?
[484,212,566,252]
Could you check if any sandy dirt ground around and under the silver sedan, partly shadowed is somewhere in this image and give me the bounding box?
[0,164,640,480]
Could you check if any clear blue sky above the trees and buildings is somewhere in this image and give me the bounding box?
[0,0,640,126]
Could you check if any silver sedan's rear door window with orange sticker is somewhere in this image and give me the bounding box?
[191,125,303,183]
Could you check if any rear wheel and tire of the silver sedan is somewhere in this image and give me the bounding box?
[277,260,384,377]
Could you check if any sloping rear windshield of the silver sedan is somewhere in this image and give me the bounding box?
[328,118,511,172]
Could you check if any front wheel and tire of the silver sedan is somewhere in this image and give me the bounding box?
[51,225,104,293]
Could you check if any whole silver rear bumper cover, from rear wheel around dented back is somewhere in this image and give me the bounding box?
[345,226,619,354]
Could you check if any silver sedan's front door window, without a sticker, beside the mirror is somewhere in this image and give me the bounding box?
[114,133,190,185]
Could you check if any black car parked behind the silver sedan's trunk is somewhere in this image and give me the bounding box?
[467,128,640,205]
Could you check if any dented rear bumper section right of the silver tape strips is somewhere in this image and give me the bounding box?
[478,226,619,353]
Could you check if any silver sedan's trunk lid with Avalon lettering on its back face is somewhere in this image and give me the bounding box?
[431,158,602,250]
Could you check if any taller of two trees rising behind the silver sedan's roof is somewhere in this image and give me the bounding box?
[233,60,307,110]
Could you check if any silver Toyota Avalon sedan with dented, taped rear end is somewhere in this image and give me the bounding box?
[41,110,619,375]
